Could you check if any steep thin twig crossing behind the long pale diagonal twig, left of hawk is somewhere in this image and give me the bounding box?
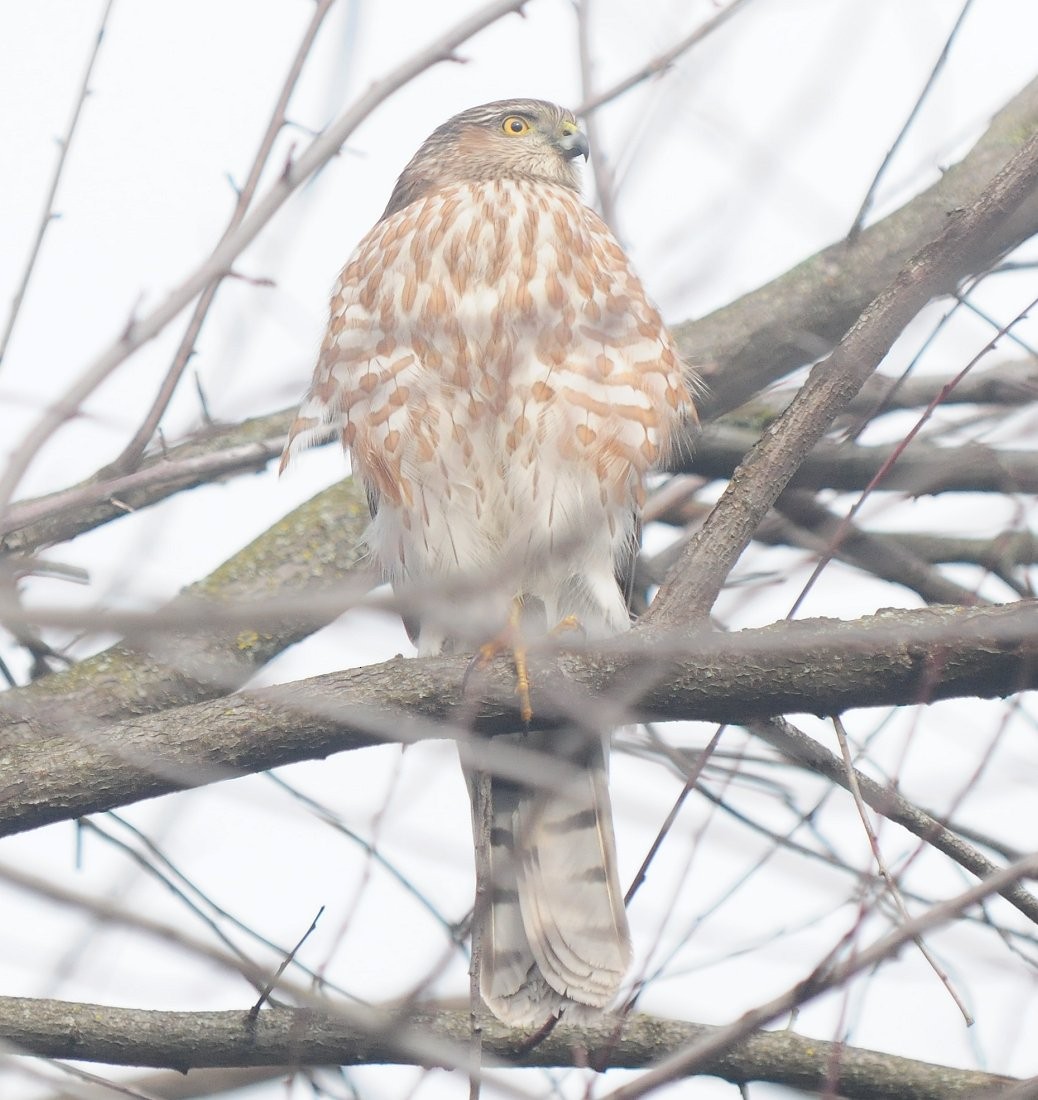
[111,0,335,473]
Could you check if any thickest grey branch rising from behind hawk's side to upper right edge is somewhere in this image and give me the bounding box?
[675,72,1038,419]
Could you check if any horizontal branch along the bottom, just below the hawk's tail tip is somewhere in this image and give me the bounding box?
[0,998,1013,1100]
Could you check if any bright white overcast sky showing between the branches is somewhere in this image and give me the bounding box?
[0,0,1038,1098]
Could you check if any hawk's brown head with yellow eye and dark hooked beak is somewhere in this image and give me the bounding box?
[383,99,588,218]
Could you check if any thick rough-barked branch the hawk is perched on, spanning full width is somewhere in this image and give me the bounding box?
[0,603,1038,835]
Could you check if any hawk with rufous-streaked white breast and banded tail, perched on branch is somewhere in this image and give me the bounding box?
[281,99,695,1026]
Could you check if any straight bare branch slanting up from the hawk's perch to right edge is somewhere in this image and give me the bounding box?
[645,121,1038,627]
